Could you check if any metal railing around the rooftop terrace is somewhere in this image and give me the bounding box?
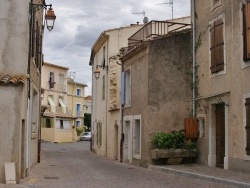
[128,20,191,49]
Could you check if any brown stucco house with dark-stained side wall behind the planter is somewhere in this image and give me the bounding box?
[121,29,192,167]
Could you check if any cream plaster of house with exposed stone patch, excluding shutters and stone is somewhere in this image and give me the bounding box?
[91,25,142,159]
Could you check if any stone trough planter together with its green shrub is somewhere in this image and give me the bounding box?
[151,131,197,164]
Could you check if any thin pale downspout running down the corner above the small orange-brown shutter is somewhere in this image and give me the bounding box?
[191,0,198,118]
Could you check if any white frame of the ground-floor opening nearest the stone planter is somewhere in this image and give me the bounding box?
[133,115,142,160]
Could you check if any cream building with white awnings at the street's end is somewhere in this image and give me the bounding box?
[41,63,77,143]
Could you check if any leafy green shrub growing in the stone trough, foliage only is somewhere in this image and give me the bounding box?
[151,131,196,149]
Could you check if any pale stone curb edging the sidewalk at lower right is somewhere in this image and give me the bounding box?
[148,165,250,188]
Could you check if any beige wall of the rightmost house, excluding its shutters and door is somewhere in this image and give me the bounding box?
[195,0,250,171]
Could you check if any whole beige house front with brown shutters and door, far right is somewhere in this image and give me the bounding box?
[192,0,250,172]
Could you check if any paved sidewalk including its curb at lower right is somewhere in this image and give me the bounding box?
[148,164,250,188]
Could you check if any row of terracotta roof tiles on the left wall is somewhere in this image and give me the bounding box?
[0,74,27,85]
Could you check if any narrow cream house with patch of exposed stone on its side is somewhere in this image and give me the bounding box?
[90,25,142,159]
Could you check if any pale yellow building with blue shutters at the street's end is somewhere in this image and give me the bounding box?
[67,78,88,127]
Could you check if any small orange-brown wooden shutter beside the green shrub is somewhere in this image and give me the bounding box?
[184,118,199,139]
